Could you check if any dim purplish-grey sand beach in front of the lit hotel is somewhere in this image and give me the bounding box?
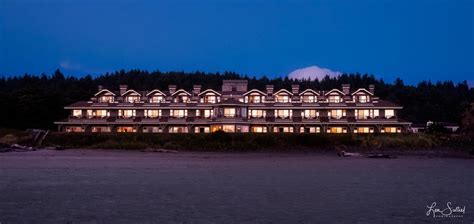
[0,150,474,224]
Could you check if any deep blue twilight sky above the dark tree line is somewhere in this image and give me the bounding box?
[0,0,474,83]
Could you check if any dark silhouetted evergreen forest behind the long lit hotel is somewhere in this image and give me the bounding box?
[0,70,474,130]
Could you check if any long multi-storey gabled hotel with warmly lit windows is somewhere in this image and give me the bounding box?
[55,80,411,133]
